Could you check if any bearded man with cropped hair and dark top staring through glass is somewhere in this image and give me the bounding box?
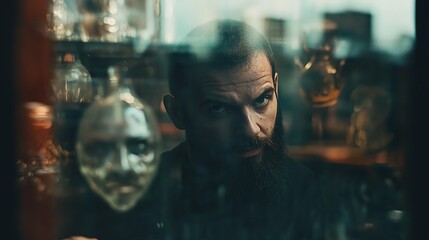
[159,20,323,240]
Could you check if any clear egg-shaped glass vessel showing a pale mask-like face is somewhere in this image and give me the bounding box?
[76,67,160,212]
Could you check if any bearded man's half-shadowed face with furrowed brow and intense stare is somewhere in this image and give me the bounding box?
[184,53,277,166]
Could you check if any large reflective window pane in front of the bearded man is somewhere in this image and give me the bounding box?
[17,0,416,240]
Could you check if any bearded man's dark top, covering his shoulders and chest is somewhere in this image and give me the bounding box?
[153,143,323,240]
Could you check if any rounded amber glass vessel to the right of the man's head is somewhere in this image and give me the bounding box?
[295,33,346,141]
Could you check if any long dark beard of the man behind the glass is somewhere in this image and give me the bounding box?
[188,108,287,195]
